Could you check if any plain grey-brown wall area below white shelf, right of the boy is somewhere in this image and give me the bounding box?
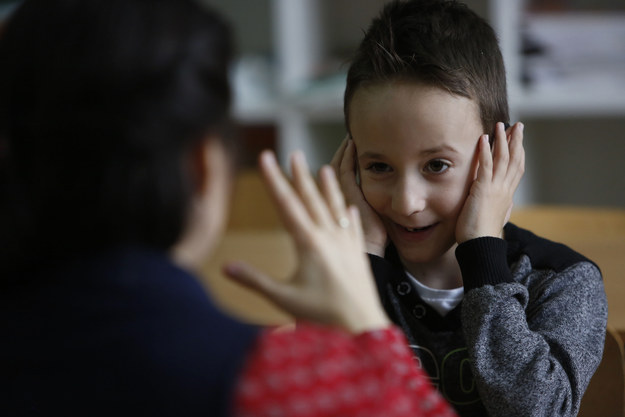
[525,117,625,208]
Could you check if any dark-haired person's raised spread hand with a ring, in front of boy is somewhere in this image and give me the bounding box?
[225,151,389,333]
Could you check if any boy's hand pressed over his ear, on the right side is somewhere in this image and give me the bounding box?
[456,123,525,243]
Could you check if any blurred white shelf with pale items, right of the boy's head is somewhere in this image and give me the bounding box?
[510,12,625,117]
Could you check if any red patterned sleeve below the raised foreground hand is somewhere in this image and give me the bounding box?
[234,324,456,417]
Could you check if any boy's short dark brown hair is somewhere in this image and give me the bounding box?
[344,0,509,134]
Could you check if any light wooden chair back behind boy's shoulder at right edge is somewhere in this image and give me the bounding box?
[511,206,625,417]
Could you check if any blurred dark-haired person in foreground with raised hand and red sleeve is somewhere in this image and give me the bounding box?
[0,0,453,416]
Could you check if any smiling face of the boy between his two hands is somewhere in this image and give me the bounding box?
[350,82,483,269]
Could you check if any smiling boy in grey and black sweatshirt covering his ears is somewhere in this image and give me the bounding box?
[333,0,607,416]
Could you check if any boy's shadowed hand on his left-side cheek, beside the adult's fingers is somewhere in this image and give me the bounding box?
[330,137,387,257]
